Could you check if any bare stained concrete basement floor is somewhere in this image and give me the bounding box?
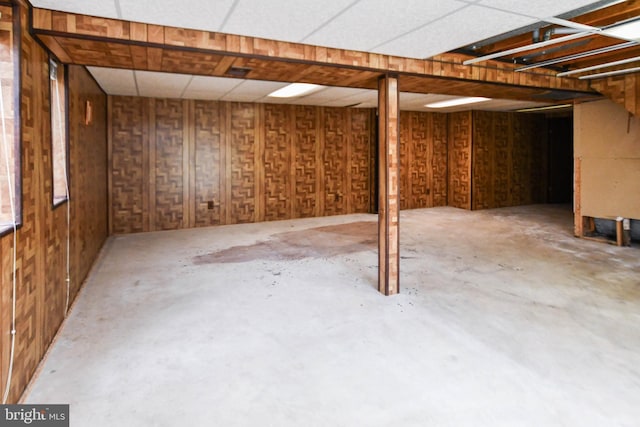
[25,206,640,427]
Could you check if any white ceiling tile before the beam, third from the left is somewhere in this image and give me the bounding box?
[222,0,353,42]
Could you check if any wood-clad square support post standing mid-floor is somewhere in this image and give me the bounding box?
[378,75,400,295]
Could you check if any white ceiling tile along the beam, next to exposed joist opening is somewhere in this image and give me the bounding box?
[373,6,537,58]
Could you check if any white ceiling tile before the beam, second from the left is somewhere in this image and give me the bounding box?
[117,0,235,31]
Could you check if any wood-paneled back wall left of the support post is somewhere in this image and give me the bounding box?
[109,97,375,233]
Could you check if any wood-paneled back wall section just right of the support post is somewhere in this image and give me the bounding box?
[400,111,448,209]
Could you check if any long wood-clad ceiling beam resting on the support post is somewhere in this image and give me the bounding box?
[33,8,590,98]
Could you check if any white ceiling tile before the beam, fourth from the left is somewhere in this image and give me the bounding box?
[304,0,465,51]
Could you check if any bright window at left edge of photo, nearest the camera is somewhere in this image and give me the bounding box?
[0,5,22,235]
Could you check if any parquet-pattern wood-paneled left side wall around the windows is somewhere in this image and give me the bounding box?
[0,0,107,402]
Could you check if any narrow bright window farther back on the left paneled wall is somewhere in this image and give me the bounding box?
[49,59,69,206]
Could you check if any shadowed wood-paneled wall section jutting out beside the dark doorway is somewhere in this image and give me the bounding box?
[448,111,548,209]
